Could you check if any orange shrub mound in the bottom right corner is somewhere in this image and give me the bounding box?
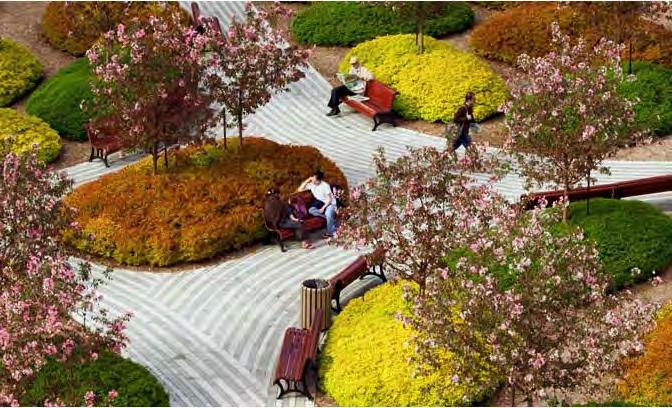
[618,305,672,406]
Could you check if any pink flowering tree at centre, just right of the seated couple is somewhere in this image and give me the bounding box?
[337,147,504,295]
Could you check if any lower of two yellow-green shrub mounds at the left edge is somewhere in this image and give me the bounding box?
[0,108,63,163]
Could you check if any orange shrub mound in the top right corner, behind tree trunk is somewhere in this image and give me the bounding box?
[470,3,672,67]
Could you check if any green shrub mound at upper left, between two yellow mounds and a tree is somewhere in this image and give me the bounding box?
[26,58,93,141]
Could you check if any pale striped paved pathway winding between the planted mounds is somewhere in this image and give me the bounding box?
[59,2,672,406]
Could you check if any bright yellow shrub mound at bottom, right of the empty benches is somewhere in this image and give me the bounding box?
[319,283,496,406]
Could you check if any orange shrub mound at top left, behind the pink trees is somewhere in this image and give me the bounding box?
[42,1,190,56]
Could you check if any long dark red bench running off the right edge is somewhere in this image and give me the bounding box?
[521,175,672,210]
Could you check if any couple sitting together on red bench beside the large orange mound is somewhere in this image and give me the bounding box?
[264,170,344,249]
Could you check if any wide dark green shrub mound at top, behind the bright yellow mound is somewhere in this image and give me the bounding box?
[292,1,474,46]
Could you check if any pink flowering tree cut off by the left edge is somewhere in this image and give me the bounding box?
[0,148,130,405]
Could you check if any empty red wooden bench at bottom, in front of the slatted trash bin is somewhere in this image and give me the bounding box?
[273,309,323,400]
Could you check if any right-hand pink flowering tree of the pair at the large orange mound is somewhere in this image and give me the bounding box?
[197,2,309,147]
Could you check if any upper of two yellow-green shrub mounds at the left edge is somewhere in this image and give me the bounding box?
[0,37,44,107]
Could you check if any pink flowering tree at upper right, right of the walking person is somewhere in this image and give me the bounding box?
[504,23,642,219]
